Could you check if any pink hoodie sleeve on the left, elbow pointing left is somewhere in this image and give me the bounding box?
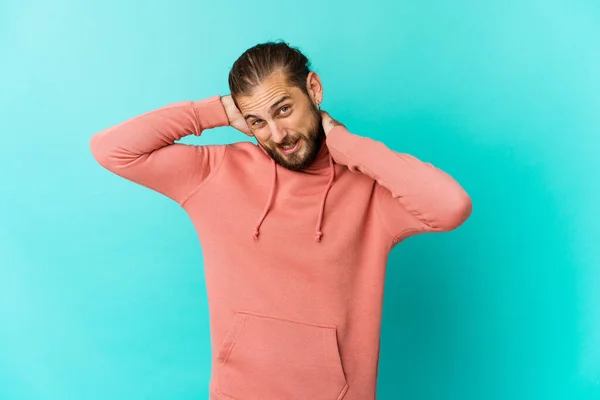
[90,95,229,205]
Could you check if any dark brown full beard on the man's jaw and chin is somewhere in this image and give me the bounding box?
[259,104,325,171]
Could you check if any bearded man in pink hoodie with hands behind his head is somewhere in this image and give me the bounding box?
[91,42,471,400]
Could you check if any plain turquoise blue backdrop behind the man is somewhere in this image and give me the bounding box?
[0,0,600,400]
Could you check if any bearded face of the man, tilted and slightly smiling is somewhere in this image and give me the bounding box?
[237,73,325,171]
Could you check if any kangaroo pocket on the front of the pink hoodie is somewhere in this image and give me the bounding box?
[216,311,348,400]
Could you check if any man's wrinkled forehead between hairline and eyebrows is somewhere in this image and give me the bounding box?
[237,73,300,116]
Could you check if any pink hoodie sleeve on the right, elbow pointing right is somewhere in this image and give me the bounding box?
[326,125,472,245]
